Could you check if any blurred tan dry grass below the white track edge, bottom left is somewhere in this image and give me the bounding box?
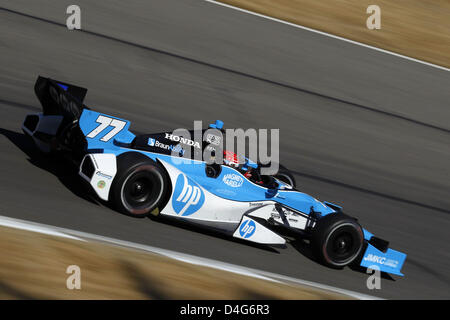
[0,227,346,299]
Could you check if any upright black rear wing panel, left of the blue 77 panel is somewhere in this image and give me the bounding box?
[34,76,88,121]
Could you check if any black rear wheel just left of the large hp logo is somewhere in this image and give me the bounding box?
[110,152,170,217]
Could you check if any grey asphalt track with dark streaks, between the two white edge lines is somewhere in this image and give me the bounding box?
[0,0,450,299]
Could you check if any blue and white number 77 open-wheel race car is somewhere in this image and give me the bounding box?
[22,76,406,276]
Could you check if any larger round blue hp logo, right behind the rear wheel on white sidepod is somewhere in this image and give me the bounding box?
[172,173,205,216]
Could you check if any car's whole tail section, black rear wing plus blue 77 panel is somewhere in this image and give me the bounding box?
[28,76,135,150]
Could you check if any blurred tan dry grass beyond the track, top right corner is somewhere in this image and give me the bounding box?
[219,0,450,67]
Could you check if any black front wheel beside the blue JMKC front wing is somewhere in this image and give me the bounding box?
[311,213,364,268]
